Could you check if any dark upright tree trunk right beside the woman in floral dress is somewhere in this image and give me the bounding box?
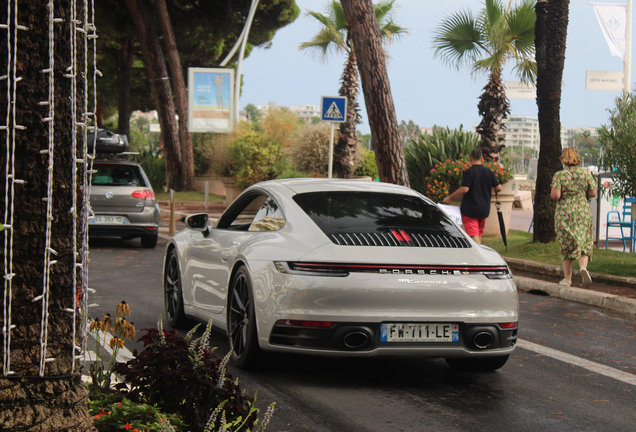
[532,0,569,243]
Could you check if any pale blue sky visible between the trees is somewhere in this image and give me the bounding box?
[239,0,636,134]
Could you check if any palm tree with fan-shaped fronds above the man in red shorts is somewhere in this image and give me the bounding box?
[433,0,537,160]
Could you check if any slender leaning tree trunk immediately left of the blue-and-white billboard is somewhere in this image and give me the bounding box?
[155,0,194,190]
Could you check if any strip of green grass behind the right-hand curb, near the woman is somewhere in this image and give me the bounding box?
[482,230,636,277]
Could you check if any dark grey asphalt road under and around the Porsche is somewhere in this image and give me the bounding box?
[89,239,636,432]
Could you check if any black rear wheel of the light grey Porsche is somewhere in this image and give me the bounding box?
[227,266,261,369]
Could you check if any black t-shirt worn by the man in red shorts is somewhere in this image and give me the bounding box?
[461,165,499,218]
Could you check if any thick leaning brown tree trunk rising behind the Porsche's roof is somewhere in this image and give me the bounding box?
[342,0,409,186]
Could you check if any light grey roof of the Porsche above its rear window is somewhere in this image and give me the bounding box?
[254,178,419,196]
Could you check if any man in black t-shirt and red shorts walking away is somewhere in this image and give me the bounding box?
[442,149,501,244]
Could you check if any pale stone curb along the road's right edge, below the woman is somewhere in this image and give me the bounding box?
[514,276,636,316]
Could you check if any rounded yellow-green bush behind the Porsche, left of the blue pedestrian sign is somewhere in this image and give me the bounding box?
[228,131,284,189]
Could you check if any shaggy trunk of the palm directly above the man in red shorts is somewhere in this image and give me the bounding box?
[477,71,510,161]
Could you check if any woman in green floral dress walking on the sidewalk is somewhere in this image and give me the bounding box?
[550,148,596,286]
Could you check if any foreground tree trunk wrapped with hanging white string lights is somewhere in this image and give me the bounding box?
[0,0,95,431]
